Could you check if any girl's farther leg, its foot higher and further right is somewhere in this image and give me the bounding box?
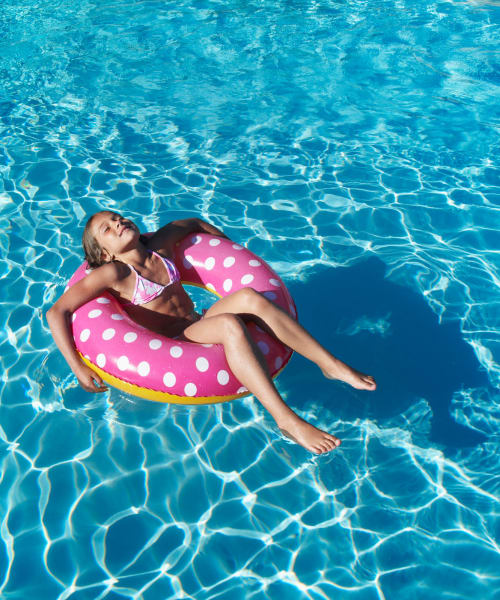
[202,288,377,390]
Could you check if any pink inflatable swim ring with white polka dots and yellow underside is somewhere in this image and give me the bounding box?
[68,233,297,404]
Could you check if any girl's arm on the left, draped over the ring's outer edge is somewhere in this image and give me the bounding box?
[46,263,123,392]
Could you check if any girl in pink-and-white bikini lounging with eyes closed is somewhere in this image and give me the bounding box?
[47,211,376,454]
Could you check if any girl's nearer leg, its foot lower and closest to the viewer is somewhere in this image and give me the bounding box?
[181,312,340,454]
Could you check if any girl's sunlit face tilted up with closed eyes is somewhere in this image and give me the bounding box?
[91,211,140,260]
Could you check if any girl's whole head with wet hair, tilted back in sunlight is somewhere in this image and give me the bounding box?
[82,210,140,269]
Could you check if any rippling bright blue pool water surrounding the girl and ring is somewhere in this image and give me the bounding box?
[0,0,500,600]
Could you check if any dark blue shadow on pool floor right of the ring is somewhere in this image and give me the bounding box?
[283,258,491,449]
